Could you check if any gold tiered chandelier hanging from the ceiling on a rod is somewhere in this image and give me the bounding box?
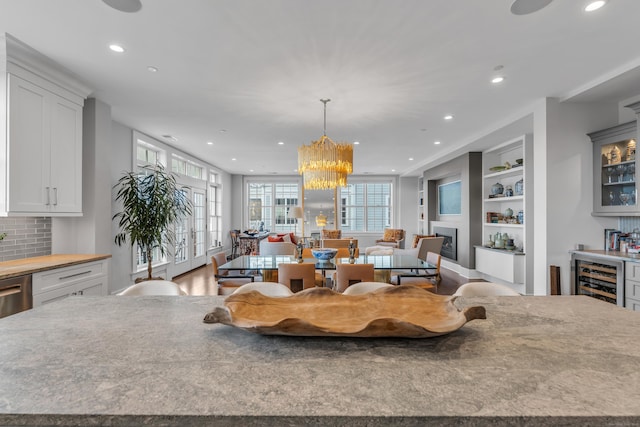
[298,99,353,190]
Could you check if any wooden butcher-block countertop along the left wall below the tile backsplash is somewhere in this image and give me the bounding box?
[0,254,111,280]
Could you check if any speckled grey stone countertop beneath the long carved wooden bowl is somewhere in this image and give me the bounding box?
[0,296,640,426]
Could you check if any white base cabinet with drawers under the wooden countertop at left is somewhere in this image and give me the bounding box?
[32,259,109,307]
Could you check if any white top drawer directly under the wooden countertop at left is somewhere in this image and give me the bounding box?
[32,260,108,295]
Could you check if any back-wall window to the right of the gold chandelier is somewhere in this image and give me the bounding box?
[340,182,392,234]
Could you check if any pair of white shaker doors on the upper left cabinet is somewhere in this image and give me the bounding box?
[7,74,82,215]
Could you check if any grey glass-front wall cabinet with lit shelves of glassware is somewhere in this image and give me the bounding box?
[589,121,640,216]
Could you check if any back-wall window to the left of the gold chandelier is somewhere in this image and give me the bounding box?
[247,182,299,232]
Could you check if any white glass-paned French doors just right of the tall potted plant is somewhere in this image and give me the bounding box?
[172,188,207,277]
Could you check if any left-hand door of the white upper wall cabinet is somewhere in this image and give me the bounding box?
[7,74,51,213]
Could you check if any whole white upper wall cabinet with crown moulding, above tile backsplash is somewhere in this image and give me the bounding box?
[0,34,88,216]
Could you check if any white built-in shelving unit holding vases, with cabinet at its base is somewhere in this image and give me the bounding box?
[476,135,533,293]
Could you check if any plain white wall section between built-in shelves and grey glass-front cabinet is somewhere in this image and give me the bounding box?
[534,98,618,295]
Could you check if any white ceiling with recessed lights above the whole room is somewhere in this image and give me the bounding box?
[0,0,640,175]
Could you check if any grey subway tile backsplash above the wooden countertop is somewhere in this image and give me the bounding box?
[0,217,51,261]
